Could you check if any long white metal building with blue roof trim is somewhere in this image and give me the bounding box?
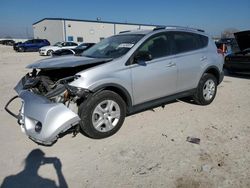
[33,18,160,44]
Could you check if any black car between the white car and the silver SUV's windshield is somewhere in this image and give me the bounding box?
[52,43,95,56]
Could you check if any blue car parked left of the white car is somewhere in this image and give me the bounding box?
[13,39,50,52]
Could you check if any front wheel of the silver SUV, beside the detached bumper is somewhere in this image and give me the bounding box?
[78,90,126,139]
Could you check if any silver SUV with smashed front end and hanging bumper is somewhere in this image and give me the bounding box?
[5,27,223,145]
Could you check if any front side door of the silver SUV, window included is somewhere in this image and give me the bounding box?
[131,33,177,105]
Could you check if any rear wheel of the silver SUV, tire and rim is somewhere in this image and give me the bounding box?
[194,73,217,105]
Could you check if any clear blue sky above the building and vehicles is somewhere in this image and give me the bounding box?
[0,0,250,38]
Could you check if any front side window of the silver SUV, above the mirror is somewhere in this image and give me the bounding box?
[139,34,171,59]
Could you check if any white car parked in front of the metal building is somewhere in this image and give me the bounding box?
[39,42,78,56]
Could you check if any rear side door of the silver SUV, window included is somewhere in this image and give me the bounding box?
[172,32,208,92]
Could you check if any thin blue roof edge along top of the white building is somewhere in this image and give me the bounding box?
[32,18,161,27]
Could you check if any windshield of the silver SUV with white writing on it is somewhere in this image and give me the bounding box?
[82,34,144,59]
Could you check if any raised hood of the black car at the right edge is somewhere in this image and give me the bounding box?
[234,30,250,51]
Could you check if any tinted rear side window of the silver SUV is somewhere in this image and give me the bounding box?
[173,32,208,54]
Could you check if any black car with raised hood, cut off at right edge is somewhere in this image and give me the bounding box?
[224,30,250,73]
